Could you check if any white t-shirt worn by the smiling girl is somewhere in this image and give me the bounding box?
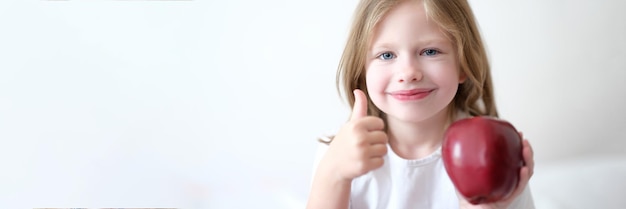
[314,143,535,209]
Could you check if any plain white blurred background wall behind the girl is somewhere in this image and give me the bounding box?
[0,0,626,208]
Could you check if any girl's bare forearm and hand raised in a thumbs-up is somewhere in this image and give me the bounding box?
[307,89,387,209]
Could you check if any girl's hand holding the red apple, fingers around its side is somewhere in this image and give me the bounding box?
[459,132,535,209]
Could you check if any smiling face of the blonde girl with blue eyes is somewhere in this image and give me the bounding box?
[366,1,462,122]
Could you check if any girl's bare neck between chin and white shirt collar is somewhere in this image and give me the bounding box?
[387,108,450,159]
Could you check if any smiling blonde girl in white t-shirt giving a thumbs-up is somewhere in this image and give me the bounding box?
[307,0,534,209]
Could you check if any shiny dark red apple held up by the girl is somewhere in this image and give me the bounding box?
[441,116,524,204]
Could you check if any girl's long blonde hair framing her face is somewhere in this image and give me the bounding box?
[337,0,498,122]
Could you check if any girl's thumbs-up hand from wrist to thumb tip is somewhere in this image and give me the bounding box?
[320,89,387,181]
